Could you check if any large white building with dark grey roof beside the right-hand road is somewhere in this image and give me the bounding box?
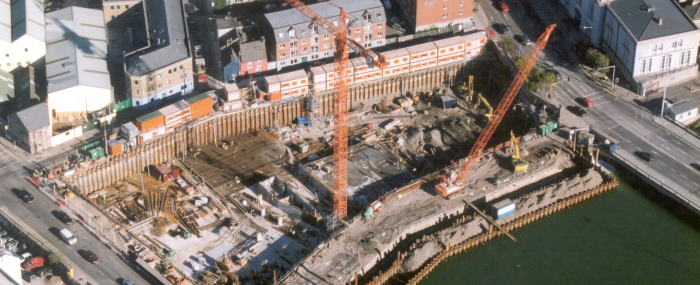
[560,0,700,92]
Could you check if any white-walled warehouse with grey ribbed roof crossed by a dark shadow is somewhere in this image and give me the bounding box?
[46,7,112,119]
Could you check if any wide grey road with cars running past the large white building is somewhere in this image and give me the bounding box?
[482,0,700,196]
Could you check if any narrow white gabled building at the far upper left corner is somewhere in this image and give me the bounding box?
[9,0,46,69]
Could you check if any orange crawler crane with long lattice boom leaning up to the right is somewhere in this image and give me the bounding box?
[435,24,556,198]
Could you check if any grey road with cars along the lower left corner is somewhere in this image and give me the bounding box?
[0,146,149,284]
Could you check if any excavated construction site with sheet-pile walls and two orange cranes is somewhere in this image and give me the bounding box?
[53,5,624,284]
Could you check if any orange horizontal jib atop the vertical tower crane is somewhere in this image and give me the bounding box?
[284,0,386,69]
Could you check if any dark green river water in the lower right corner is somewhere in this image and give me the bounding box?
[421,170,700,285]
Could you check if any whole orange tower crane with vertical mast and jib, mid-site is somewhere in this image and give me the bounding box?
[284,0,386,219]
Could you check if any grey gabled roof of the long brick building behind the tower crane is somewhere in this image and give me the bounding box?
[265,0,386,43]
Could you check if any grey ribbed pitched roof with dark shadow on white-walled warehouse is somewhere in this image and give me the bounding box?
[46,7,112,93]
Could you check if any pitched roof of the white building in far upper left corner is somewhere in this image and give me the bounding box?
[12,0,45,41]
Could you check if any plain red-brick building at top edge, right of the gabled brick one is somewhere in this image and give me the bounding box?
[398,0,474,32]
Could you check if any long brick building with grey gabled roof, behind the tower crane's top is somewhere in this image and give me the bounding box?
[265,0,386,71]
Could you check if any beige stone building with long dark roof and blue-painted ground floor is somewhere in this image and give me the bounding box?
[124,0,194,109]
